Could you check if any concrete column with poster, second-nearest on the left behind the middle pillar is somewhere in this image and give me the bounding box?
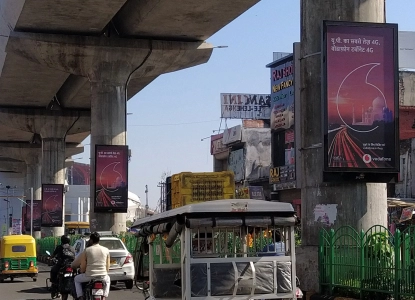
[42,137,66,236]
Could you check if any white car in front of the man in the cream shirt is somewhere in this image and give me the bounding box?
[74,235,135,289]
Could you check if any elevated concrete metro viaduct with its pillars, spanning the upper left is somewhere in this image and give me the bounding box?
[0,0,259,235]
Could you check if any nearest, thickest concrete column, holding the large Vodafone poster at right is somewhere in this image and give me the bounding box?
[297,0,387,291]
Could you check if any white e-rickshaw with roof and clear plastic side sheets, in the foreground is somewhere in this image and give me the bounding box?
[132,199,298,300]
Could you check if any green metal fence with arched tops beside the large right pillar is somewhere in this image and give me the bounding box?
[319,225,415,300]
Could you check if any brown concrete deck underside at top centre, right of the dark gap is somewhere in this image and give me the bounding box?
[114,0,259,41]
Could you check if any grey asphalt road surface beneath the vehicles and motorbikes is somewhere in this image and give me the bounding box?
[0,263,148,300]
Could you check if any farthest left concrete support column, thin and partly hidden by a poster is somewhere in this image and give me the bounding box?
[25,155,42,239]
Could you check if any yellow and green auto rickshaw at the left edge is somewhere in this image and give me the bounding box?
[0,235,38,282]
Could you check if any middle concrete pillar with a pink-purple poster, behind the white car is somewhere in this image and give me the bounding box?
[89,61,131,233]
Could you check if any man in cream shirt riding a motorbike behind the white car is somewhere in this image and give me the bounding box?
[75,232,111,300]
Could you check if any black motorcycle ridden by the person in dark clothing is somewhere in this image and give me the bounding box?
[46,251,76,300]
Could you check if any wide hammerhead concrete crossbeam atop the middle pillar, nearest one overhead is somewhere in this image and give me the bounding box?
[6,32,213,80]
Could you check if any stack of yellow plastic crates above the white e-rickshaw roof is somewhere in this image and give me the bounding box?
[171,171,235,208]
